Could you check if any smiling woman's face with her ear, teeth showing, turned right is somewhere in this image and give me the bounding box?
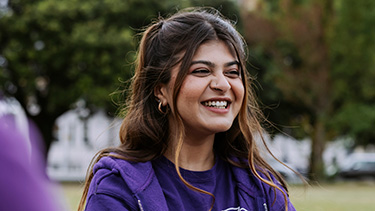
[158,40,244,135]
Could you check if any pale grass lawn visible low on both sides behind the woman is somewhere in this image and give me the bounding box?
[62,182,375,211]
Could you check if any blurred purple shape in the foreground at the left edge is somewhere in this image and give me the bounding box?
[0,98,61,211]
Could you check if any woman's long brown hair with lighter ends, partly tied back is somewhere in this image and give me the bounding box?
[78,8,287,210]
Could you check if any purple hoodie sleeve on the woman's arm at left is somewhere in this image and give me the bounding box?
[85,169,137,211]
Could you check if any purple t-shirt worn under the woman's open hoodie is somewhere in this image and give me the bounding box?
[153,157,239,211]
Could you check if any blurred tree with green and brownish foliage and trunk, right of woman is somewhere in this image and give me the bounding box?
[241,0,375,180]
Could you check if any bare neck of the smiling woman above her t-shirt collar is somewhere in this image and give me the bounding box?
[165,135,215,171]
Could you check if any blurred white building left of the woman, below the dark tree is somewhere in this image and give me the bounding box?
[47,102,121,181]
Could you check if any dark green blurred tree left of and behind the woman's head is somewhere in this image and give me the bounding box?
[0,0,239,157]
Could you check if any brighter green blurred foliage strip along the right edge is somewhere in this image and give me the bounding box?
[330,0,375,145]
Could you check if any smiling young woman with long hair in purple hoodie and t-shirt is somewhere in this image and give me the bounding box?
[79,9,295,211]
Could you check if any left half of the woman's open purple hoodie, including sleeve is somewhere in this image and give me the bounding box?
[87,156,167,210]
